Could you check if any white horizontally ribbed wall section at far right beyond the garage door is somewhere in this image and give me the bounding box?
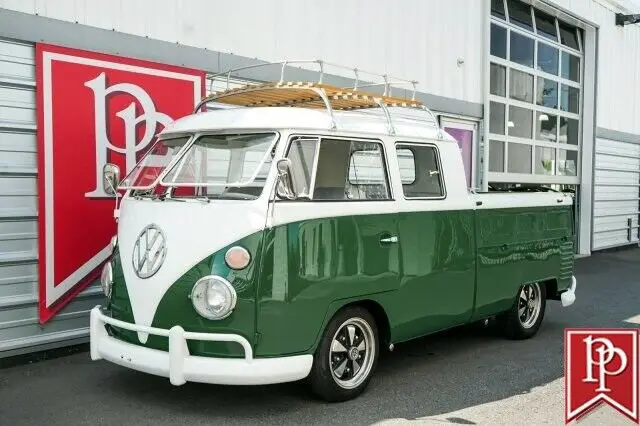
[592,138,640,250]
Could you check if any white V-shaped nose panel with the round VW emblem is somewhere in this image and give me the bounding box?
[118,198,267,343]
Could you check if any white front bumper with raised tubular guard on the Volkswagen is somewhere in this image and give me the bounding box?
[90,306,313,385]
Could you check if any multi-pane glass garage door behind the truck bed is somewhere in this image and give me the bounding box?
[487,0,584,184]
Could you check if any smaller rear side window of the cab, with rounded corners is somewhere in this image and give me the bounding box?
[396,144,444,198]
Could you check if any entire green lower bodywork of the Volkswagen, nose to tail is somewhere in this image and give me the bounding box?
[108,201,573,357]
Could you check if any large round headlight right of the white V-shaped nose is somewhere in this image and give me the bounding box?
[191,276,237,320]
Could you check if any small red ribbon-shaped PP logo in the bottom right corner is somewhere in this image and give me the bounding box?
[565,329,640,423]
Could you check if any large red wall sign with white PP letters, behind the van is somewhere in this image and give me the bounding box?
[36,44,205,323]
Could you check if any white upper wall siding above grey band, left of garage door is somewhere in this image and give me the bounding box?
[0,0,485,103]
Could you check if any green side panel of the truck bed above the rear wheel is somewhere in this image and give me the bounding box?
[474,206,574,318]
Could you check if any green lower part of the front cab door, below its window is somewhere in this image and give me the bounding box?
[257,214,401,356]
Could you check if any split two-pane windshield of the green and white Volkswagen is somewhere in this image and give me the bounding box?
[123,132,277,199]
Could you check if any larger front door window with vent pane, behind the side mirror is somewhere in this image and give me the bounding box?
[287,138,391,201]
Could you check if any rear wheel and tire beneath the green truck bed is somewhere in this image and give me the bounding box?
[497,282,547,340]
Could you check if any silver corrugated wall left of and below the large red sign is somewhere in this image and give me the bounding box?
[0,39,101,358]
